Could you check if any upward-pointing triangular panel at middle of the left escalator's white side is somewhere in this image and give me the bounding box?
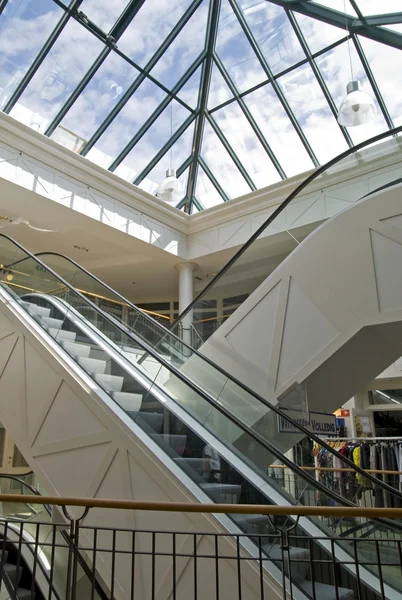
[35,382,106,446]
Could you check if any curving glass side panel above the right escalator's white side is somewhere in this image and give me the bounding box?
[171,127,402,348]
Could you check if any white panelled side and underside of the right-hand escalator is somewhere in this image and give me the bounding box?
[180,185,402,449]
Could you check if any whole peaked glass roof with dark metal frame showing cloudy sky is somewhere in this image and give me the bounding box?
[0,0,402,213]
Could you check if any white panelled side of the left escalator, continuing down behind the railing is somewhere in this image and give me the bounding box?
[0,290,282,600]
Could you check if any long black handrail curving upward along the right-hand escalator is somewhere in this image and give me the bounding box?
[174,125,402,329]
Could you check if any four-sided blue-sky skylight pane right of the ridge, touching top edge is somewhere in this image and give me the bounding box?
[237,0,306,73]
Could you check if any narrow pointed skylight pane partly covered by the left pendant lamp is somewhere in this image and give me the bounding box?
[139,123,194,194]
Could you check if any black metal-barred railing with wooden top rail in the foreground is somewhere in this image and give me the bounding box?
[0,494,402,600]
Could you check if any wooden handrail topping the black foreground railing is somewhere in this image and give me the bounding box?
[0,494,402,519]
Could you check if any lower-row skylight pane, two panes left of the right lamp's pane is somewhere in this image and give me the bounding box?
[244,84,314,177]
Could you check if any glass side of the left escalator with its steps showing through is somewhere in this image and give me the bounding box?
[0,241,402,589]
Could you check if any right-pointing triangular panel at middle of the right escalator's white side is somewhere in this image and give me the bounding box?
[277,279,338,387]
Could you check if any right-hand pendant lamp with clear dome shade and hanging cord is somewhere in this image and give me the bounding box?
[338,0,377,127]
